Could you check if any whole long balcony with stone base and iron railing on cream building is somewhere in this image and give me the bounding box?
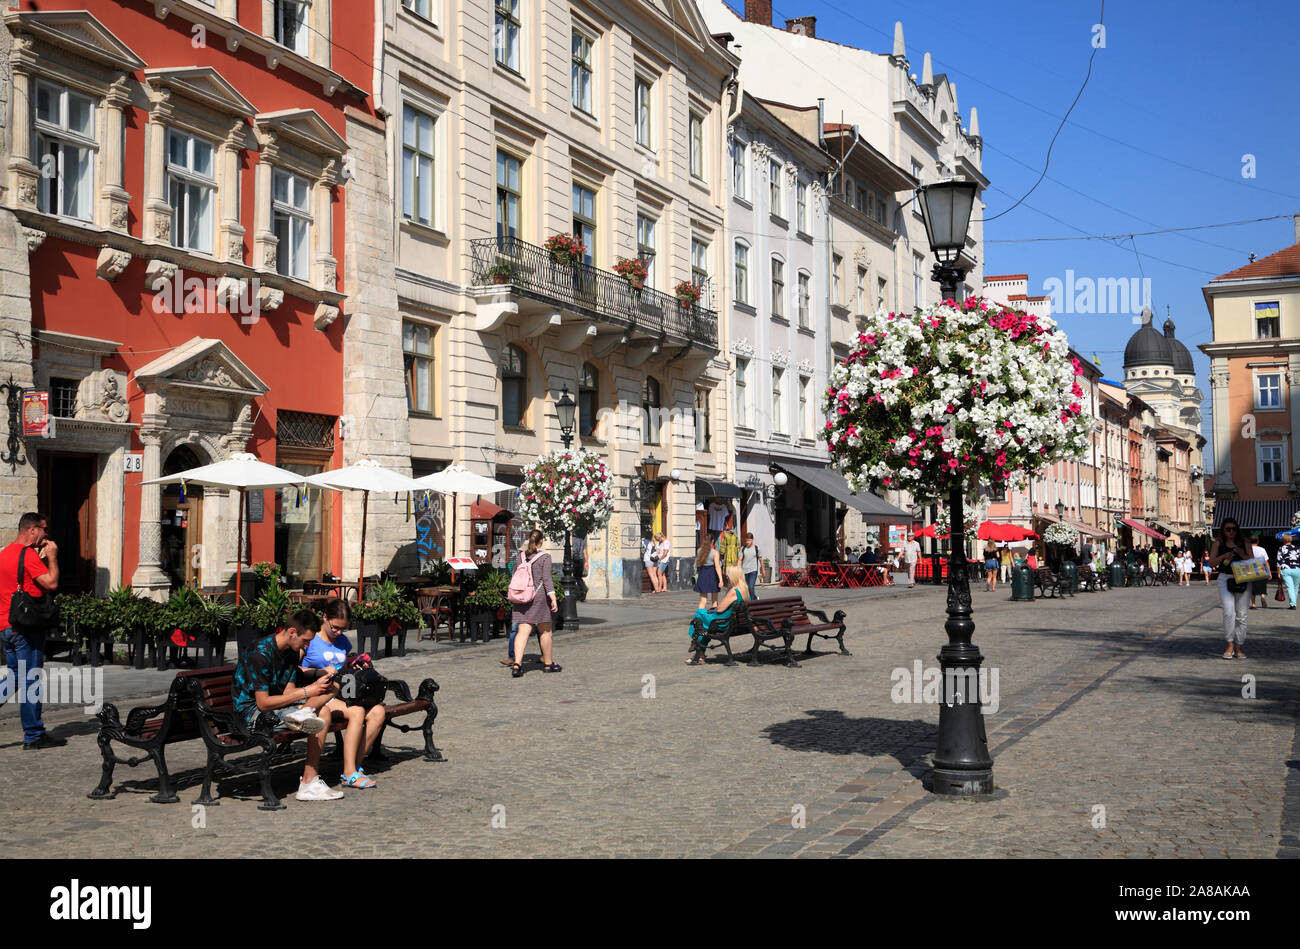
[469,238,718,355]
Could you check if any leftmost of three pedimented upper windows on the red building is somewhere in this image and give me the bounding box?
[35,79,98,221]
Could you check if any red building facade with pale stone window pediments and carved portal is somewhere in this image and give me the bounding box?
[0,0,373,595]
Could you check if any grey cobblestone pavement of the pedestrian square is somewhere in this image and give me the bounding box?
[0,584,1300,857]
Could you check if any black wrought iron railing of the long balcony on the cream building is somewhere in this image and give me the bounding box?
[469,238,718,350]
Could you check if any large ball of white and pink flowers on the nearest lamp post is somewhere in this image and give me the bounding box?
[822,296,1092,503]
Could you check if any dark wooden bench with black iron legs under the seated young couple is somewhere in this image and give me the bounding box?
[86,666,443,810]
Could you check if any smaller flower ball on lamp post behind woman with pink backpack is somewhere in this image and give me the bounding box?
[519,449,614,542]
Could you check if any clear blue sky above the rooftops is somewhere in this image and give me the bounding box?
[728,0,1300,449]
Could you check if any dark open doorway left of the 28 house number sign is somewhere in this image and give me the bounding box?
[36,451,99,593]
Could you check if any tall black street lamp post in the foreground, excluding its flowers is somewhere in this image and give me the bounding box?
[919,179,993,797]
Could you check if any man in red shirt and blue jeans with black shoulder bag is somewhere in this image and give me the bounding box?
[0,512,68,751]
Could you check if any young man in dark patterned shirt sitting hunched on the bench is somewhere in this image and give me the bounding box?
[230,610,343,801]
